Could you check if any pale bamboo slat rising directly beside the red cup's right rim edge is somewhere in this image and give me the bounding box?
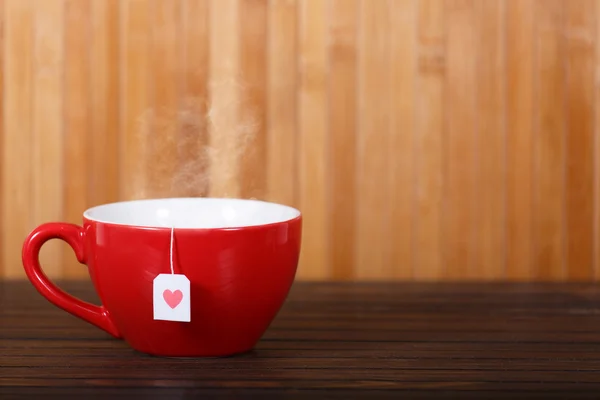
[296,0,330,279]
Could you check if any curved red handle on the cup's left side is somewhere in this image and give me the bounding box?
[22,222,121,338]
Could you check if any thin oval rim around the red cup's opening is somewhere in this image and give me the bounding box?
[82,197,303,231]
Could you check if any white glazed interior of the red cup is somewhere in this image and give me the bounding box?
[83,198,300,229]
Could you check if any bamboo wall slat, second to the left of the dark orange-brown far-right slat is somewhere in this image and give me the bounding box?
[505,0,538,280]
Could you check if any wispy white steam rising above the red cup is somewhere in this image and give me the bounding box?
[130,80,260,200]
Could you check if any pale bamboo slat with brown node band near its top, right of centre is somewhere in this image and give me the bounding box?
[414,0,446,280]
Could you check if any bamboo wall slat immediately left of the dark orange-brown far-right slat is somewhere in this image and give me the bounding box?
[533,0,566,280]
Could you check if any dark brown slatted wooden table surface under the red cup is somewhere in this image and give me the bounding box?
[0,282,600,400]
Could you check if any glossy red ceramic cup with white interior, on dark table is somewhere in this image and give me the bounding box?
[23,198,302,357]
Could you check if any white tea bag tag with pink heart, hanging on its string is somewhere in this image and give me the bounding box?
[152,228,191,322]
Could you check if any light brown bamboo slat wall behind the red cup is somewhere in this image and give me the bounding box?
[0,0,600,280]
